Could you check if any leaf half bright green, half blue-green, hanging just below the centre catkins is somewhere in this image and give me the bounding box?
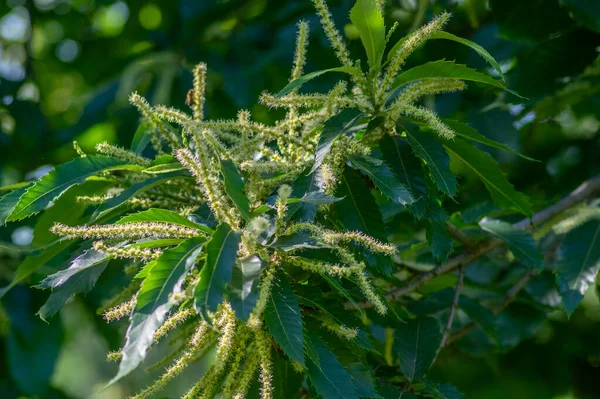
[194,223,241,321]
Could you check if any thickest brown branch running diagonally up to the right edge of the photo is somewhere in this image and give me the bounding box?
[346,174,600,309]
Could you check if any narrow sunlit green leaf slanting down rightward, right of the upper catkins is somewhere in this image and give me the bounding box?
[443,138,533,216]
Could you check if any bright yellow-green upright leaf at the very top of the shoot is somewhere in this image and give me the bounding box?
[350,0,385,70]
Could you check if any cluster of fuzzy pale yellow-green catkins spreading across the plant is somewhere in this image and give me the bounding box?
[52,0,463,399]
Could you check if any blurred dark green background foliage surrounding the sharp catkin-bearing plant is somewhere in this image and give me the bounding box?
[0,0,600,399]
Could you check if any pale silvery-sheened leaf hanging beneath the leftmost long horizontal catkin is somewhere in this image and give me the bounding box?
[36,249,110,320]
